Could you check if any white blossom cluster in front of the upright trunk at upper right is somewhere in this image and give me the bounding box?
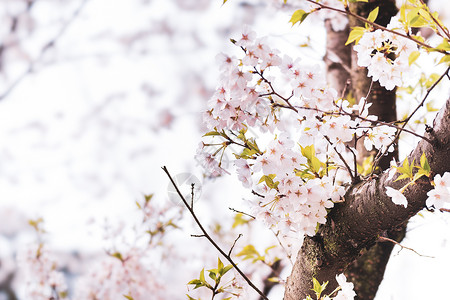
[353,18,417,90]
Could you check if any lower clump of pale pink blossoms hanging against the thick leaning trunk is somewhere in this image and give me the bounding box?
[246,138,344,236]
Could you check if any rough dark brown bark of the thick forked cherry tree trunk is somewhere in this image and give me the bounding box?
[285,0,450,300]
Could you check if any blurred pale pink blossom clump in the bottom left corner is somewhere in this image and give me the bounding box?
[17,244,67,300]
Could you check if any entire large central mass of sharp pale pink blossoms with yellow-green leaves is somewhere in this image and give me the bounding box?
[197,28,396,235]
